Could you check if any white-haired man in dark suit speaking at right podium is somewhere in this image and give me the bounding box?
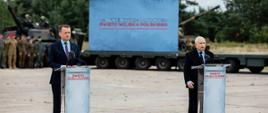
[184,36,214,113]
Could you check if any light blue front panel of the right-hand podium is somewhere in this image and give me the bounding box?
[203,65,226,113]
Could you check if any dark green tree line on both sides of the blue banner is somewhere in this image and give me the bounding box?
[0,0,268,43]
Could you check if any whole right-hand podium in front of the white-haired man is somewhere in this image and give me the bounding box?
[192,64,229,113]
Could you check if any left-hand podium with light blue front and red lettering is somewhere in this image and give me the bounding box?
[61,66,90,113]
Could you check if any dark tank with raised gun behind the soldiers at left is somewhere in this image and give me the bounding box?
[2,2,85,67]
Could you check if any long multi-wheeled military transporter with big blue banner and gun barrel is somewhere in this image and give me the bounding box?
[82,0,268,73]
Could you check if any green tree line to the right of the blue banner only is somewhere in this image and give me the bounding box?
[180,0,268,43]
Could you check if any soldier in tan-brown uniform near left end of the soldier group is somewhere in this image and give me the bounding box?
[8,36,18,69]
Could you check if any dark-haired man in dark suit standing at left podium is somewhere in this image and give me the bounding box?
[48,25,80,113]
